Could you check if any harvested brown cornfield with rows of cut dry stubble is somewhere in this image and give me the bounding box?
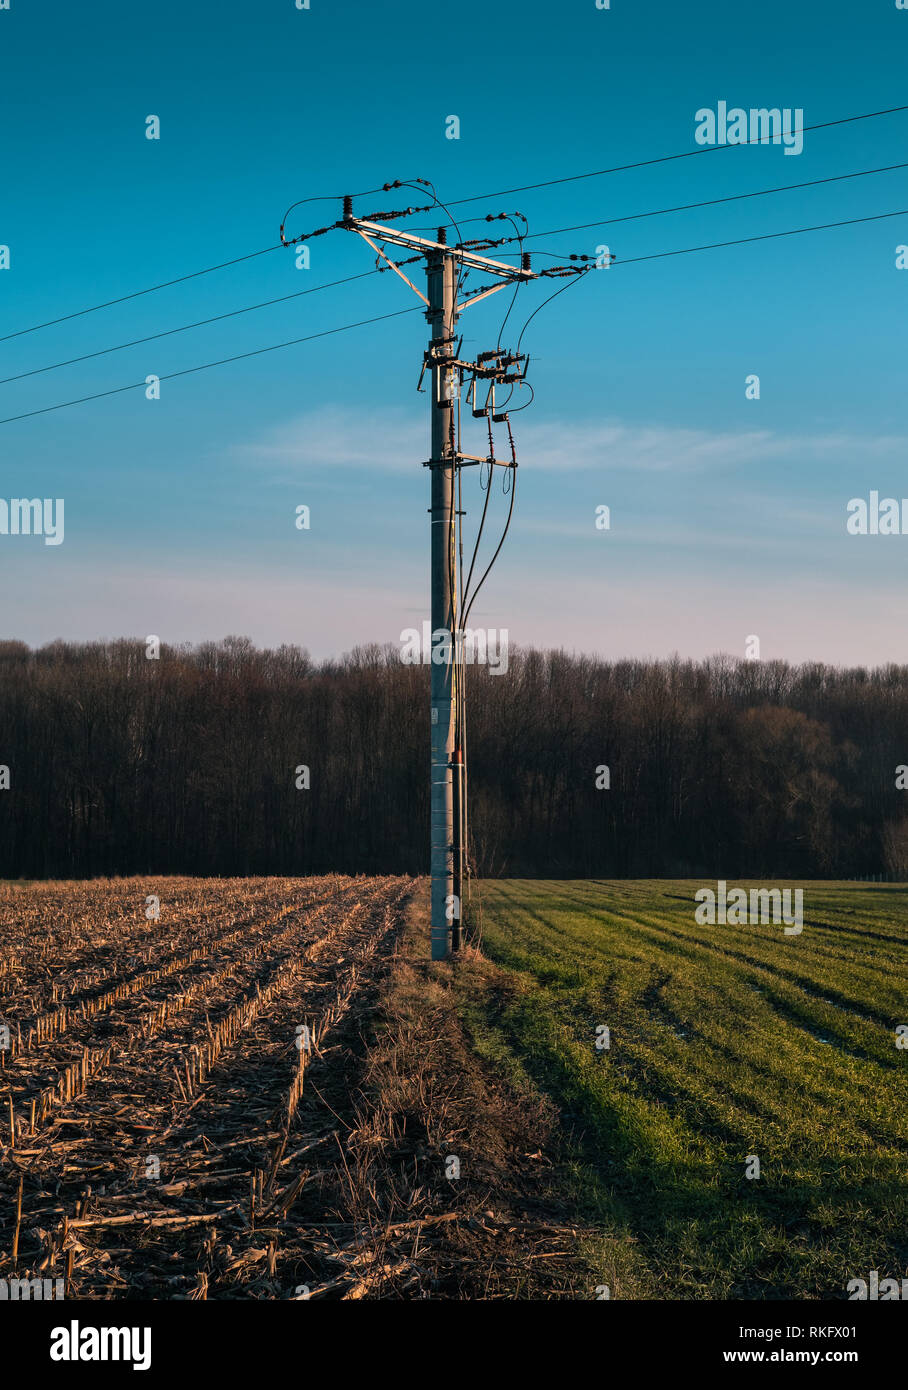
[0,876,413,1300]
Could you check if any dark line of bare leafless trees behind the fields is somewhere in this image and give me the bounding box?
[0,638,908,878]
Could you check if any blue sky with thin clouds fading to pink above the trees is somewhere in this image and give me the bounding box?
[0,0,908,663]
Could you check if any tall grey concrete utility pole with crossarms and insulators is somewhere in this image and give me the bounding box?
[339,193,537,960]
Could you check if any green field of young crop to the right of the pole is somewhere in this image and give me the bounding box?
[462,880,908,1300]
